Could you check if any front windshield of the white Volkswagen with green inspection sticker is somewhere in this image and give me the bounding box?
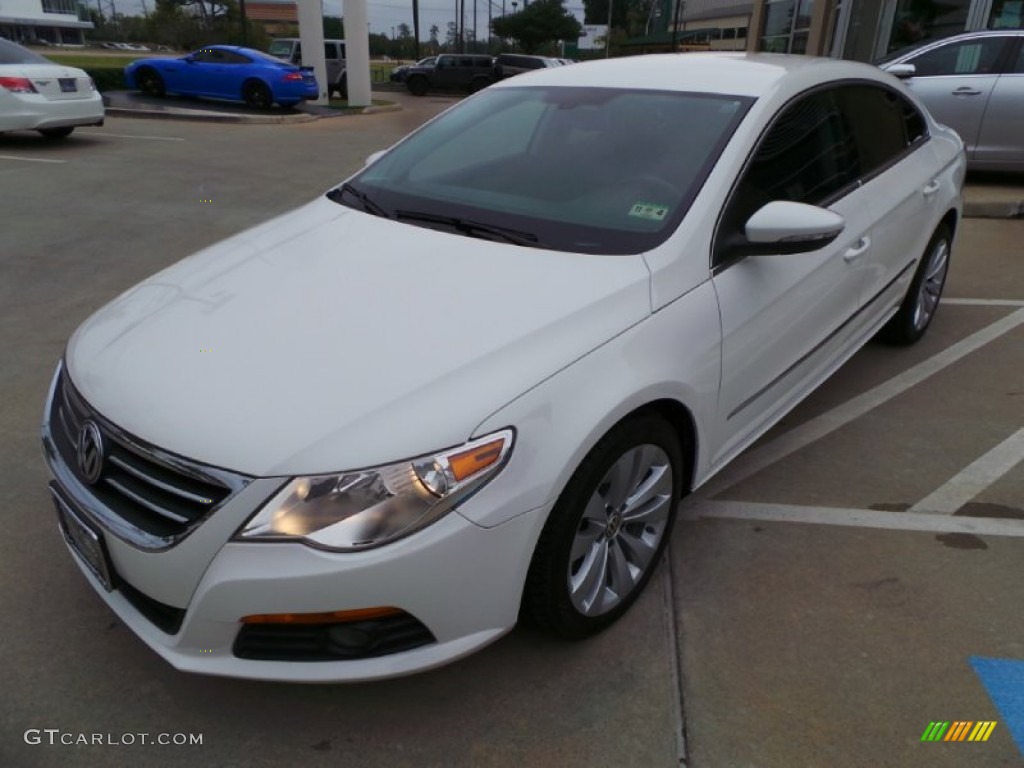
[330,86,753,254]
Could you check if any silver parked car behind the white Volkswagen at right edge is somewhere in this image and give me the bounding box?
[880,29,1024,171]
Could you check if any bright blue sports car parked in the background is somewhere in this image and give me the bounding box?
[125,45,319,110]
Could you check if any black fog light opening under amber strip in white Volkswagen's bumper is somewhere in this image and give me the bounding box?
[232,612,436,662]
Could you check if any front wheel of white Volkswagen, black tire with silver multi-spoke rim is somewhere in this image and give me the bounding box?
[521,414,684,639]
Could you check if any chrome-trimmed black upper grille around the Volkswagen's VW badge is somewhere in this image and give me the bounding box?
[50,371,249,546]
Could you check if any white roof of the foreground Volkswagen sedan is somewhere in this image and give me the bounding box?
[492,52,893,97]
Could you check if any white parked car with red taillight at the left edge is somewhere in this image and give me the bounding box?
[0,38,104,138]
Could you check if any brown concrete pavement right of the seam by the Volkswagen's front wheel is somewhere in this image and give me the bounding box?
[672,221,1024,768]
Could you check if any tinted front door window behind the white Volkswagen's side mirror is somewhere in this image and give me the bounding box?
[715,90,862,261]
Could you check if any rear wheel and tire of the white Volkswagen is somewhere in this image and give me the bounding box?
[878,223,953,346]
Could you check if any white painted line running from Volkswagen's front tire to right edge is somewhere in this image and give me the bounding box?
[680,501,1024,537]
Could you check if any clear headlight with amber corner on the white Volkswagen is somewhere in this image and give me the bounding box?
[234,429,514,552]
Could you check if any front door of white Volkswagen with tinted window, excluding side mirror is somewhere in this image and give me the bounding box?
[712,88,872,464]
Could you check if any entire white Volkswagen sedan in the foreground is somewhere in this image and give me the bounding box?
[43,54,965,681]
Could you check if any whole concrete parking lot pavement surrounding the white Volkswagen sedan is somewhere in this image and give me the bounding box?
[0,115,1024,768]
